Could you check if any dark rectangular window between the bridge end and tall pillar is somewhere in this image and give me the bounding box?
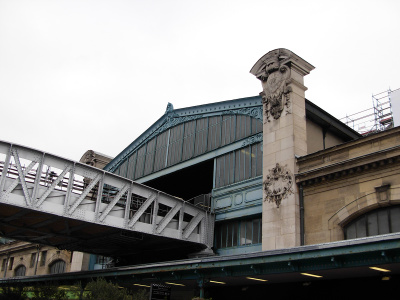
[215,217,261,249]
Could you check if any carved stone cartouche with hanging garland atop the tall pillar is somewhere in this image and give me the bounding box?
[256,51,292,122]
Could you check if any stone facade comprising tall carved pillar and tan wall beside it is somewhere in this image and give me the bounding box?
[250,49,400,250]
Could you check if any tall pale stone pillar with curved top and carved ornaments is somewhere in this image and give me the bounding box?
[250,49,314,250]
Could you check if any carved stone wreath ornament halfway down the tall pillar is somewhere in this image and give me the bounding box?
[263,164,293,208]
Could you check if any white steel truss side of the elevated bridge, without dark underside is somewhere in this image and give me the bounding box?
[0,141,214,247]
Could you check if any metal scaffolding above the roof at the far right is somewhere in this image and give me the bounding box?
[340,89,394,136]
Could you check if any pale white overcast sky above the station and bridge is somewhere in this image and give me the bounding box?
[0,0,400,160]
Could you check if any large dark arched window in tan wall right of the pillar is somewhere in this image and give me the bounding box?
[344,206,400,239]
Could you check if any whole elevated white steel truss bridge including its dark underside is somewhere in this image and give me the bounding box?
[0,141,214,262]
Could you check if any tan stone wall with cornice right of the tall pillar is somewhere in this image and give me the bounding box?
[296,127,400,244]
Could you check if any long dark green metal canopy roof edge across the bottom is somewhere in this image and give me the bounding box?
[0,233,400,285]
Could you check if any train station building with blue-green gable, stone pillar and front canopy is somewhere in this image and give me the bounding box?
[0,49,400,299]
